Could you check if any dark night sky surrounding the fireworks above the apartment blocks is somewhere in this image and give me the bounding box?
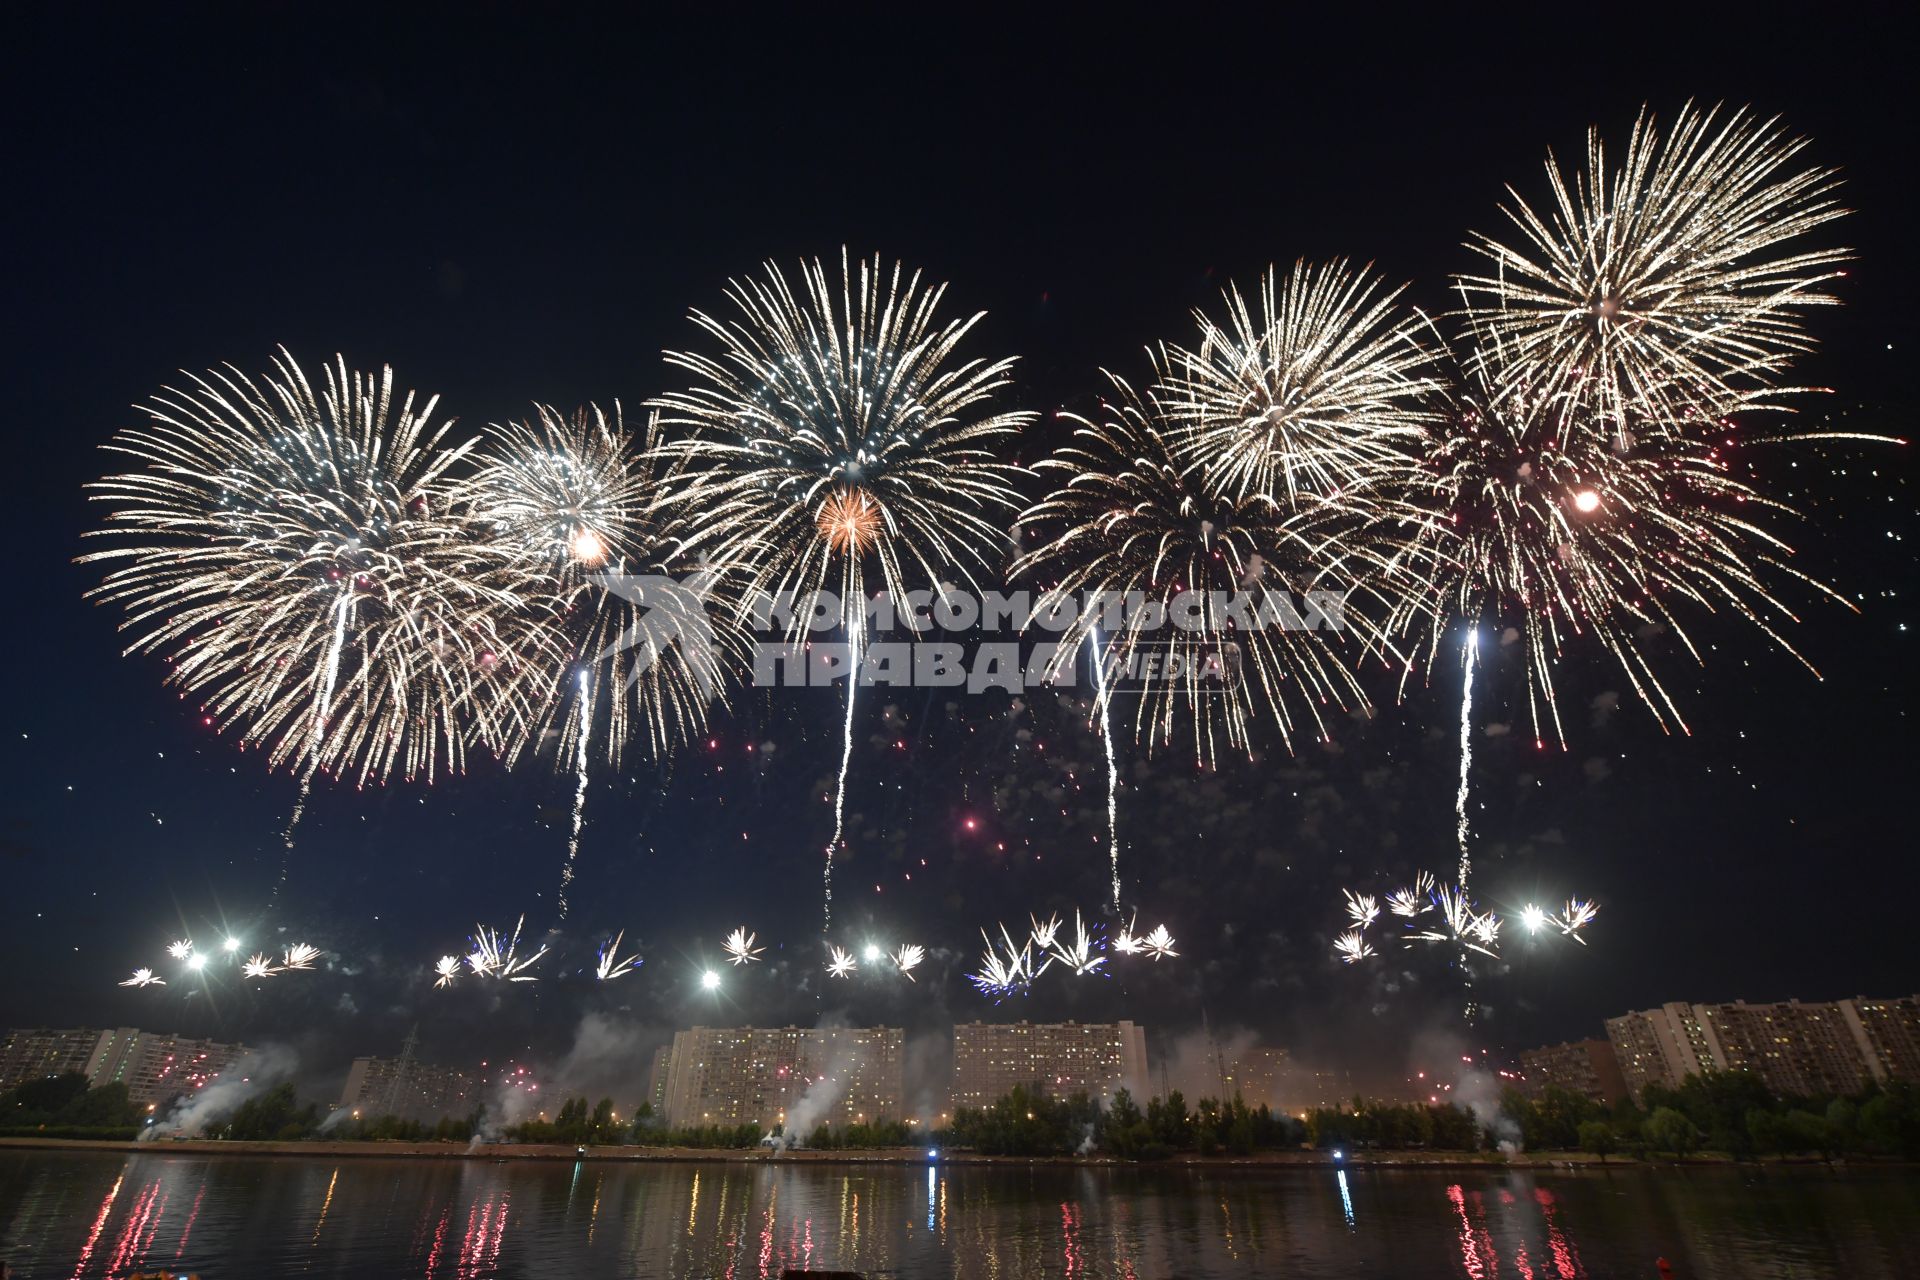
[0,6,1920,1097]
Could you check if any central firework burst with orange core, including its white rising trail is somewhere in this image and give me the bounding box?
[657,251,1033,931]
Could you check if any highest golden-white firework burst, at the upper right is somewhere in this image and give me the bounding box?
[1457,104,1851,439]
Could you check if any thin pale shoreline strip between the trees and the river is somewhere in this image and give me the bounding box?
[0,1138,1881,1173]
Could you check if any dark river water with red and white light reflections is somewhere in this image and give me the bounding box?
[0,1150,1920,1280]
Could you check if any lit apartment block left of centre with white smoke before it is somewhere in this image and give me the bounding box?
[662,1027,906,1138]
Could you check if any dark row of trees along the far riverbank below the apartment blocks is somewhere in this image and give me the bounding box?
[18,1071,1920,1161]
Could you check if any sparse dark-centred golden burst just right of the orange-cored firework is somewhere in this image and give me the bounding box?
[1014,355,1386,767]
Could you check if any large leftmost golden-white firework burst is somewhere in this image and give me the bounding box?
[81,351,547,783]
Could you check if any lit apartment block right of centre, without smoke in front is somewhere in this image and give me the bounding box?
[952,1023,1148,1109]
